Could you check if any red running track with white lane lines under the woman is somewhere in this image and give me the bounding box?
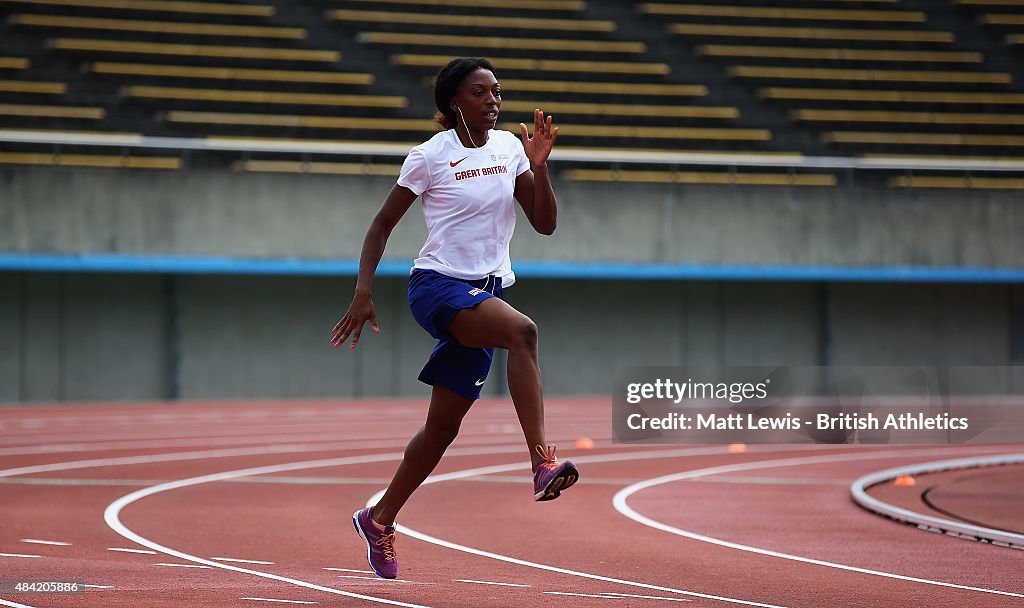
[0,398,1024,608]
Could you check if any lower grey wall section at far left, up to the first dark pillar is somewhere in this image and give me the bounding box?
[0,273,171,401]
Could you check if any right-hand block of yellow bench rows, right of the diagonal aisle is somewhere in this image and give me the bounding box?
[637,0,1024,160]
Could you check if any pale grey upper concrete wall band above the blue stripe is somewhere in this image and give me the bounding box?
[0,165,1024,268]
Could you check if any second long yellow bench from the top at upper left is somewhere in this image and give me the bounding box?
[7,14,306,40]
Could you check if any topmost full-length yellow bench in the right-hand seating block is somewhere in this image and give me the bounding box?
[638,2,926,24]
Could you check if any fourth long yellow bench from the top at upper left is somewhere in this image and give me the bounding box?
[86,61,374,85]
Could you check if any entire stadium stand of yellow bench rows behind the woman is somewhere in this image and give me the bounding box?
[0,0,1024,183]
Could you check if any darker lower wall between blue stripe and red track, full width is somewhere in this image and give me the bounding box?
[0,273,1011,401]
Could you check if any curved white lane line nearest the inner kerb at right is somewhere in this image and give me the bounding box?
[611,448,1024,598]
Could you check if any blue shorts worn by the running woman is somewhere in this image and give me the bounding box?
[409,268,502,401]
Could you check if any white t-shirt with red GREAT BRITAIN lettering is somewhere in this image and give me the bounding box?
[398,129,529,288]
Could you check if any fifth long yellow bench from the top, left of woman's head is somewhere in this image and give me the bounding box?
[121,86,409,107]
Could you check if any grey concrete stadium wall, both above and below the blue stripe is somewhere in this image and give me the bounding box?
[0,167,1024,401]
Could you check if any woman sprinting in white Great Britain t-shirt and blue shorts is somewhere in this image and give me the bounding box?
[331,57,579,578]
